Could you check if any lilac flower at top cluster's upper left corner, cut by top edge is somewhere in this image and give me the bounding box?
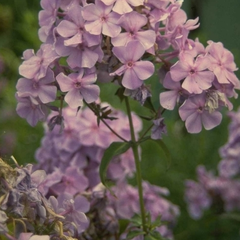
[38,0,61,27]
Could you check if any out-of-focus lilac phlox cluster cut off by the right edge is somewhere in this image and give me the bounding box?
[185,108,240,219]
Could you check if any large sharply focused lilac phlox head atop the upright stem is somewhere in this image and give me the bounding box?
[16,0,240,133]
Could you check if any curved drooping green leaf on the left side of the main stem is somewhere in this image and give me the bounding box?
[99,142,131,195]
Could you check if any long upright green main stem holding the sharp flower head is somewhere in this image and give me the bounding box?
[125,97,147,232]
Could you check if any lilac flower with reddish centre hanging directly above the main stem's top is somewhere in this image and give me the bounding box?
[110,41,154,90]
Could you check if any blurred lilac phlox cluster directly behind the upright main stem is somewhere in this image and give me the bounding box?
[32,103,179,239]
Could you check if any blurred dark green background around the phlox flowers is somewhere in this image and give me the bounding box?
[0,0,240,240]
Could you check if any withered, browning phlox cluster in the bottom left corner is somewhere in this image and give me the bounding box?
[0,159,86,240]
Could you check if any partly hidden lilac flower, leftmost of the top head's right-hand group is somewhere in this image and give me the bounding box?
[159,72,188,110]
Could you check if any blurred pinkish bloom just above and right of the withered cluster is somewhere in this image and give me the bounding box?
[51,166,88,195]
